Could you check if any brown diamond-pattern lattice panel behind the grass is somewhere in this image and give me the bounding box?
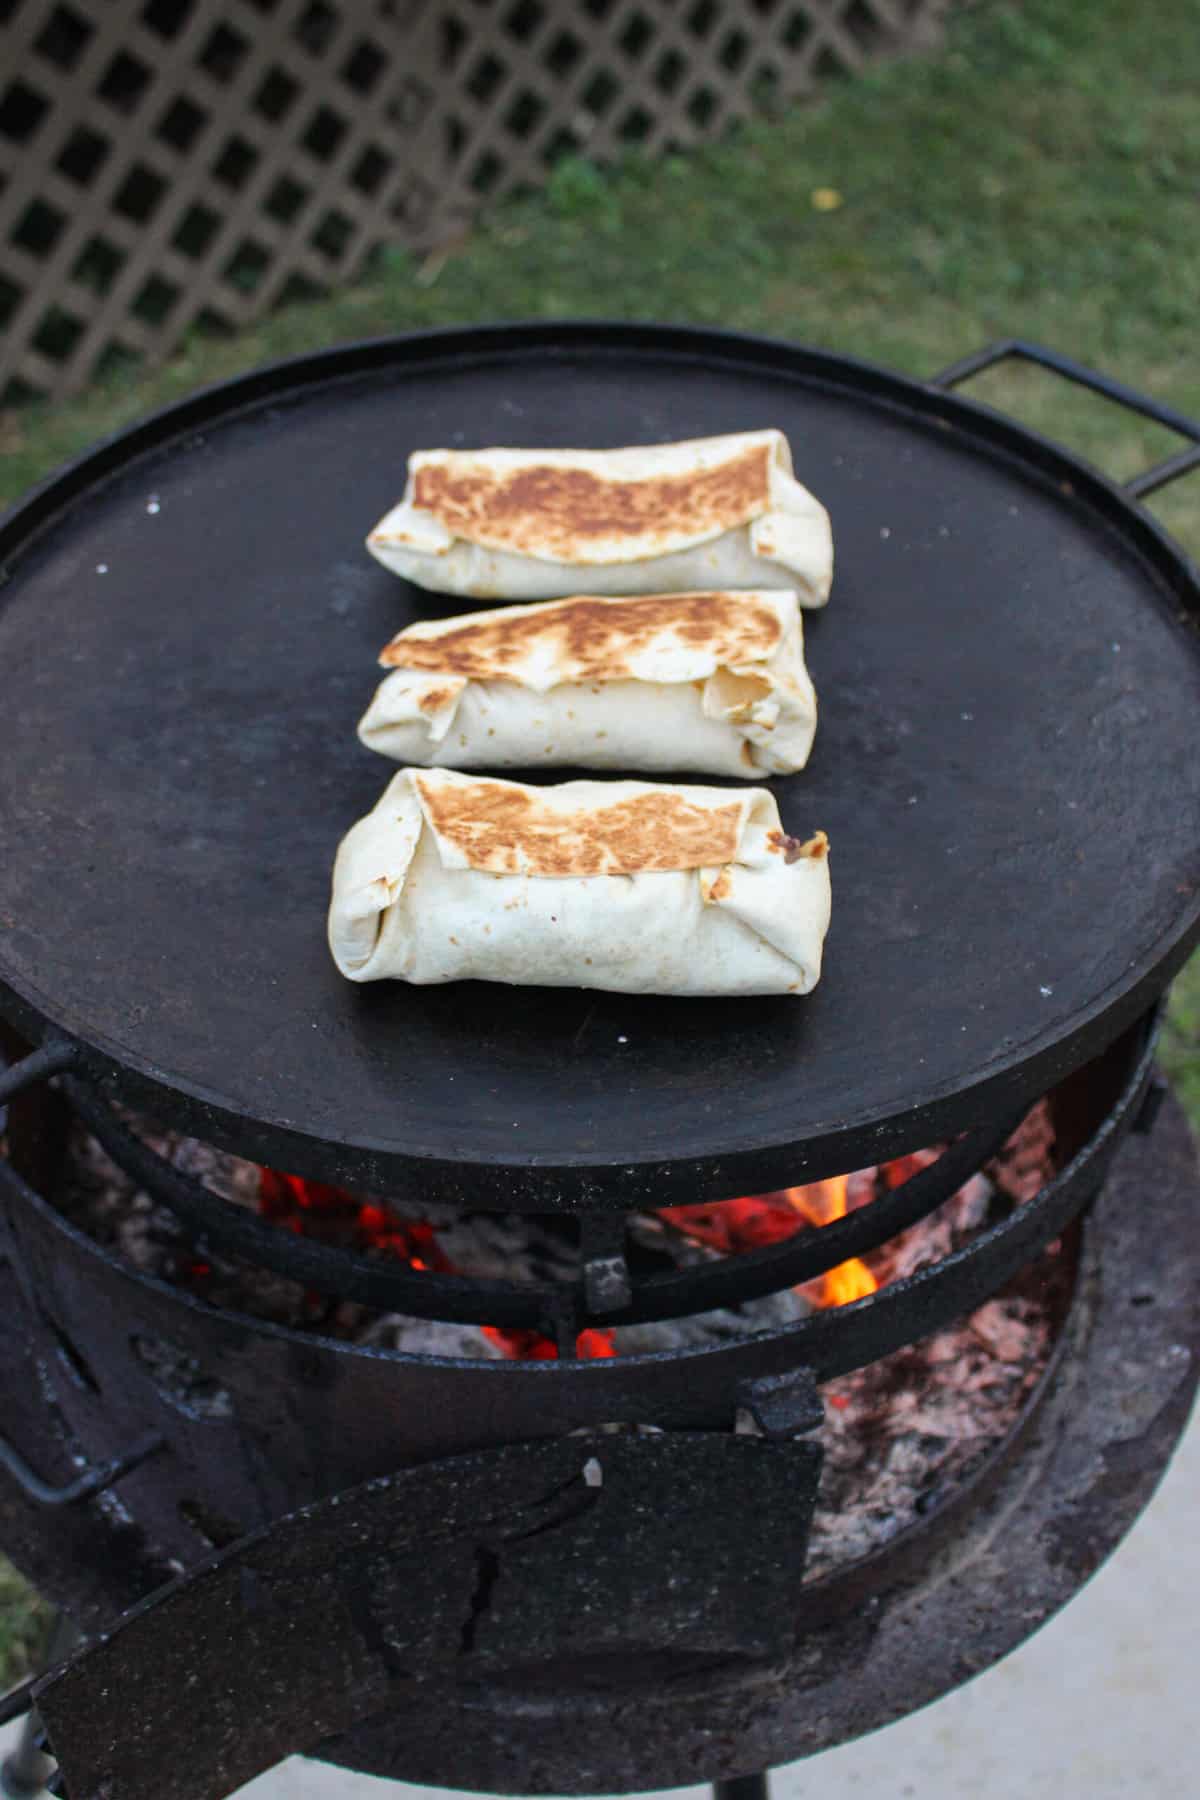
[0,0,948,398]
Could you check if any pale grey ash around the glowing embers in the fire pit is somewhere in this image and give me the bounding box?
[59,1103,1069,1580]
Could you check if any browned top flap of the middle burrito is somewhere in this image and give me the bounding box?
[380,594,783,688]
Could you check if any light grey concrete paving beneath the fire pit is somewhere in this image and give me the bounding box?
[0,1415,1200,1800]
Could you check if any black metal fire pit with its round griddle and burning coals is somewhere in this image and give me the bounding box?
[0,326,1200,1800]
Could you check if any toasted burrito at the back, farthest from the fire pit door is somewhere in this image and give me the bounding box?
[367,430,833,607]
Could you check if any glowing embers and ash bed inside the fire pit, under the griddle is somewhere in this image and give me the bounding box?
[39,1080,1074,1580]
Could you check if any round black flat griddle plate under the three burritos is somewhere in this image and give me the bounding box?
[0,324,1200,1206]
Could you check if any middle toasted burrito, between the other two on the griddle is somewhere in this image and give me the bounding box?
[358,589,817,776]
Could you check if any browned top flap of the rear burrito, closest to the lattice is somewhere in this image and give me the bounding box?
[412,445,772,562]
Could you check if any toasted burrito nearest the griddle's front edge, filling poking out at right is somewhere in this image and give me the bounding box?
[329,769,829,994]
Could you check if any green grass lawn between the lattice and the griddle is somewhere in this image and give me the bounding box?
[0,0,1200,1685]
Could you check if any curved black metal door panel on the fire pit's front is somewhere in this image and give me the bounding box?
[36,1418,820,1800]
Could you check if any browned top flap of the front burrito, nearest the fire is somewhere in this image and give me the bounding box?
[416,776,745,877]
